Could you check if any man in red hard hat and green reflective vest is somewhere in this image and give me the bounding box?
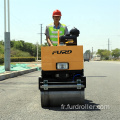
[45,10,68,46]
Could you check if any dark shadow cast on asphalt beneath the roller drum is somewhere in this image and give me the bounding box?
[43,100,101,111]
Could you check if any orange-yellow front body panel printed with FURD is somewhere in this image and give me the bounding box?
[41,46,83,71]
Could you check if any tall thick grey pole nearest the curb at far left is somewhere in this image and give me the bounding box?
[4,0,10,71]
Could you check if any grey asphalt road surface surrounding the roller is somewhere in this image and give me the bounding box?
[0,62,120,120]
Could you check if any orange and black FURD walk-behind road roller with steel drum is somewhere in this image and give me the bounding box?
[39,28,86,107]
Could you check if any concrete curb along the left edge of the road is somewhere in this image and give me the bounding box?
[0,67,41,81]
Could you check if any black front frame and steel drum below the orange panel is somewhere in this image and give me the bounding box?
[39,70,86,107]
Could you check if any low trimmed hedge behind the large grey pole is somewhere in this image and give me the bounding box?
[0,57,40,64]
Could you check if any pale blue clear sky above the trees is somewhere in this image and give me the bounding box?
[0,0,120,52]
